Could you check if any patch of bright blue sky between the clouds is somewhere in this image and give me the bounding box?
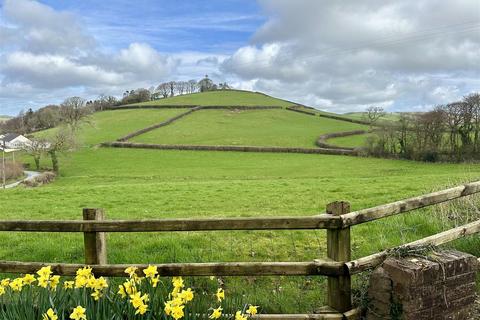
[27,0,267,54]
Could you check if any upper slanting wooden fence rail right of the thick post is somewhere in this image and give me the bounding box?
[341,181,480,227]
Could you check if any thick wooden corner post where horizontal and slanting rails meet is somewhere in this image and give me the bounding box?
[327,201,352,312]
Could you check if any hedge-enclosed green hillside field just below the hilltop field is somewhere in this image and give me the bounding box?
[132,110,367,147]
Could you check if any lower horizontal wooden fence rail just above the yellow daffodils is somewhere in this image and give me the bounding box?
[0,260,345,277]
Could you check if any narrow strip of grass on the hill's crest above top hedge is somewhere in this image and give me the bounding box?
[122,90,293,107]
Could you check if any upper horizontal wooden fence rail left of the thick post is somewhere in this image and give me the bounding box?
[0,214,341,232]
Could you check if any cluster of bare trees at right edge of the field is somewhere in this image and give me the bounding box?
[365,93,480,162]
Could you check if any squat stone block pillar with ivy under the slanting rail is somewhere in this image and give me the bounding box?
[367,250,477,320]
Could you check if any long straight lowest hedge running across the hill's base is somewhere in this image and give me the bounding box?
[101,141,357,156]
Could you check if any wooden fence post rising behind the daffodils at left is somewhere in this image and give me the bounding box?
[83,208,107,265]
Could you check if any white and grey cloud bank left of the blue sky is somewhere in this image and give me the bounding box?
[0,0,179,113]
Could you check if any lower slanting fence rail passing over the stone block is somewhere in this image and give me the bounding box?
[346,220,480,274]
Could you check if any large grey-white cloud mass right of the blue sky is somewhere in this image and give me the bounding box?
[222,0,480,112]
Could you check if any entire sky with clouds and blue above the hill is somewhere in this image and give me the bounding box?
[0,0,480,115]
